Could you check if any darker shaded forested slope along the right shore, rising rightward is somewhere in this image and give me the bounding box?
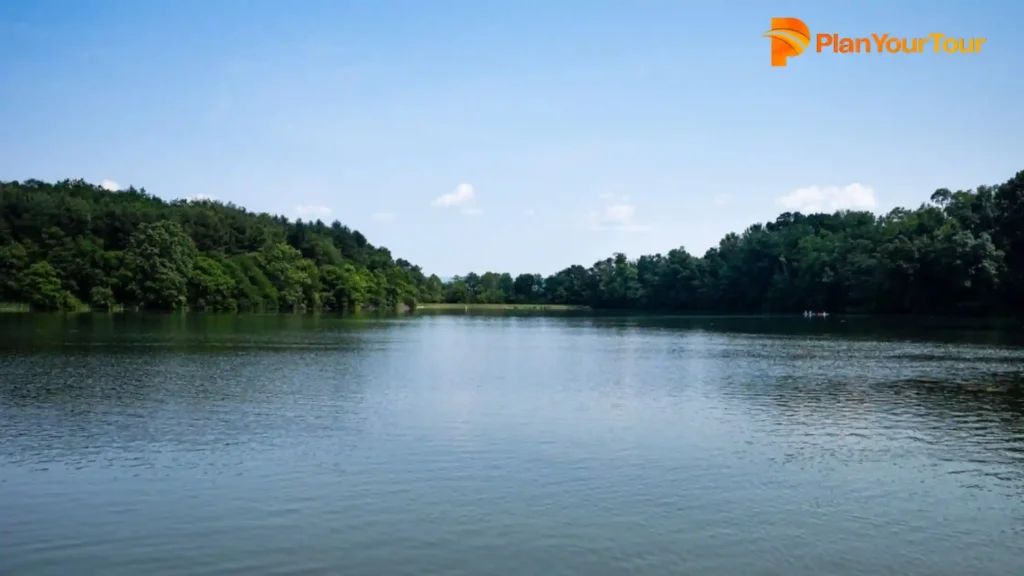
[444,171,1024,314]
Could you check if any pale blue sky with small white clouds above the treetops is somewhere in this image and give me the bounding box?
[0,0,1024,276]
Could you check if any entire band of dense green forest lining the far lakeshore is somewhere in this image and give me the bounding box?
[0,171,1024,314]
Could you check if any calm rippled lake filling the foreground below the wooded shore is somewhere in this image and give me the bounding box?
[0,314,1024,576]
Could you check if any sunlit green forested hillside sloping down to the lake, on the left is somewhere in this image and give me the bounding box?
[0,180,441,311]
